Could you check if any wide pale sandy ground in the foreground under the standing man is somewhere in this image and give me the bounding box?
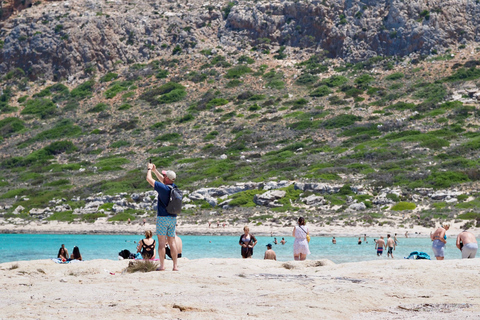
[0,259,480,320]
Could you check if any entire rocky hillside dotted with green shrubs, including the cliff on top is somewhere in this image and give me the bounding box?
[0,0,480,230]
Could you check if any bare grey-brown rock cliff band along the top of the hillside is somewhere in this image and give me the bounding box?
[0,0,480,80]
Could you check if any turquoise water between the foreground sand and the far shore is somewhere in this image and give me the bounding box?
[0,234,461,263]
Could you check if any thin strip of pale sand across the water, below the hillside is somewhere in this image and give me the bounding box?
[0,219,474,237]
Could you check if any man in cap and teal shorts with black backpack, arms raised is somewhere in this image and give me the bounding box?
[147,163,182,271]
